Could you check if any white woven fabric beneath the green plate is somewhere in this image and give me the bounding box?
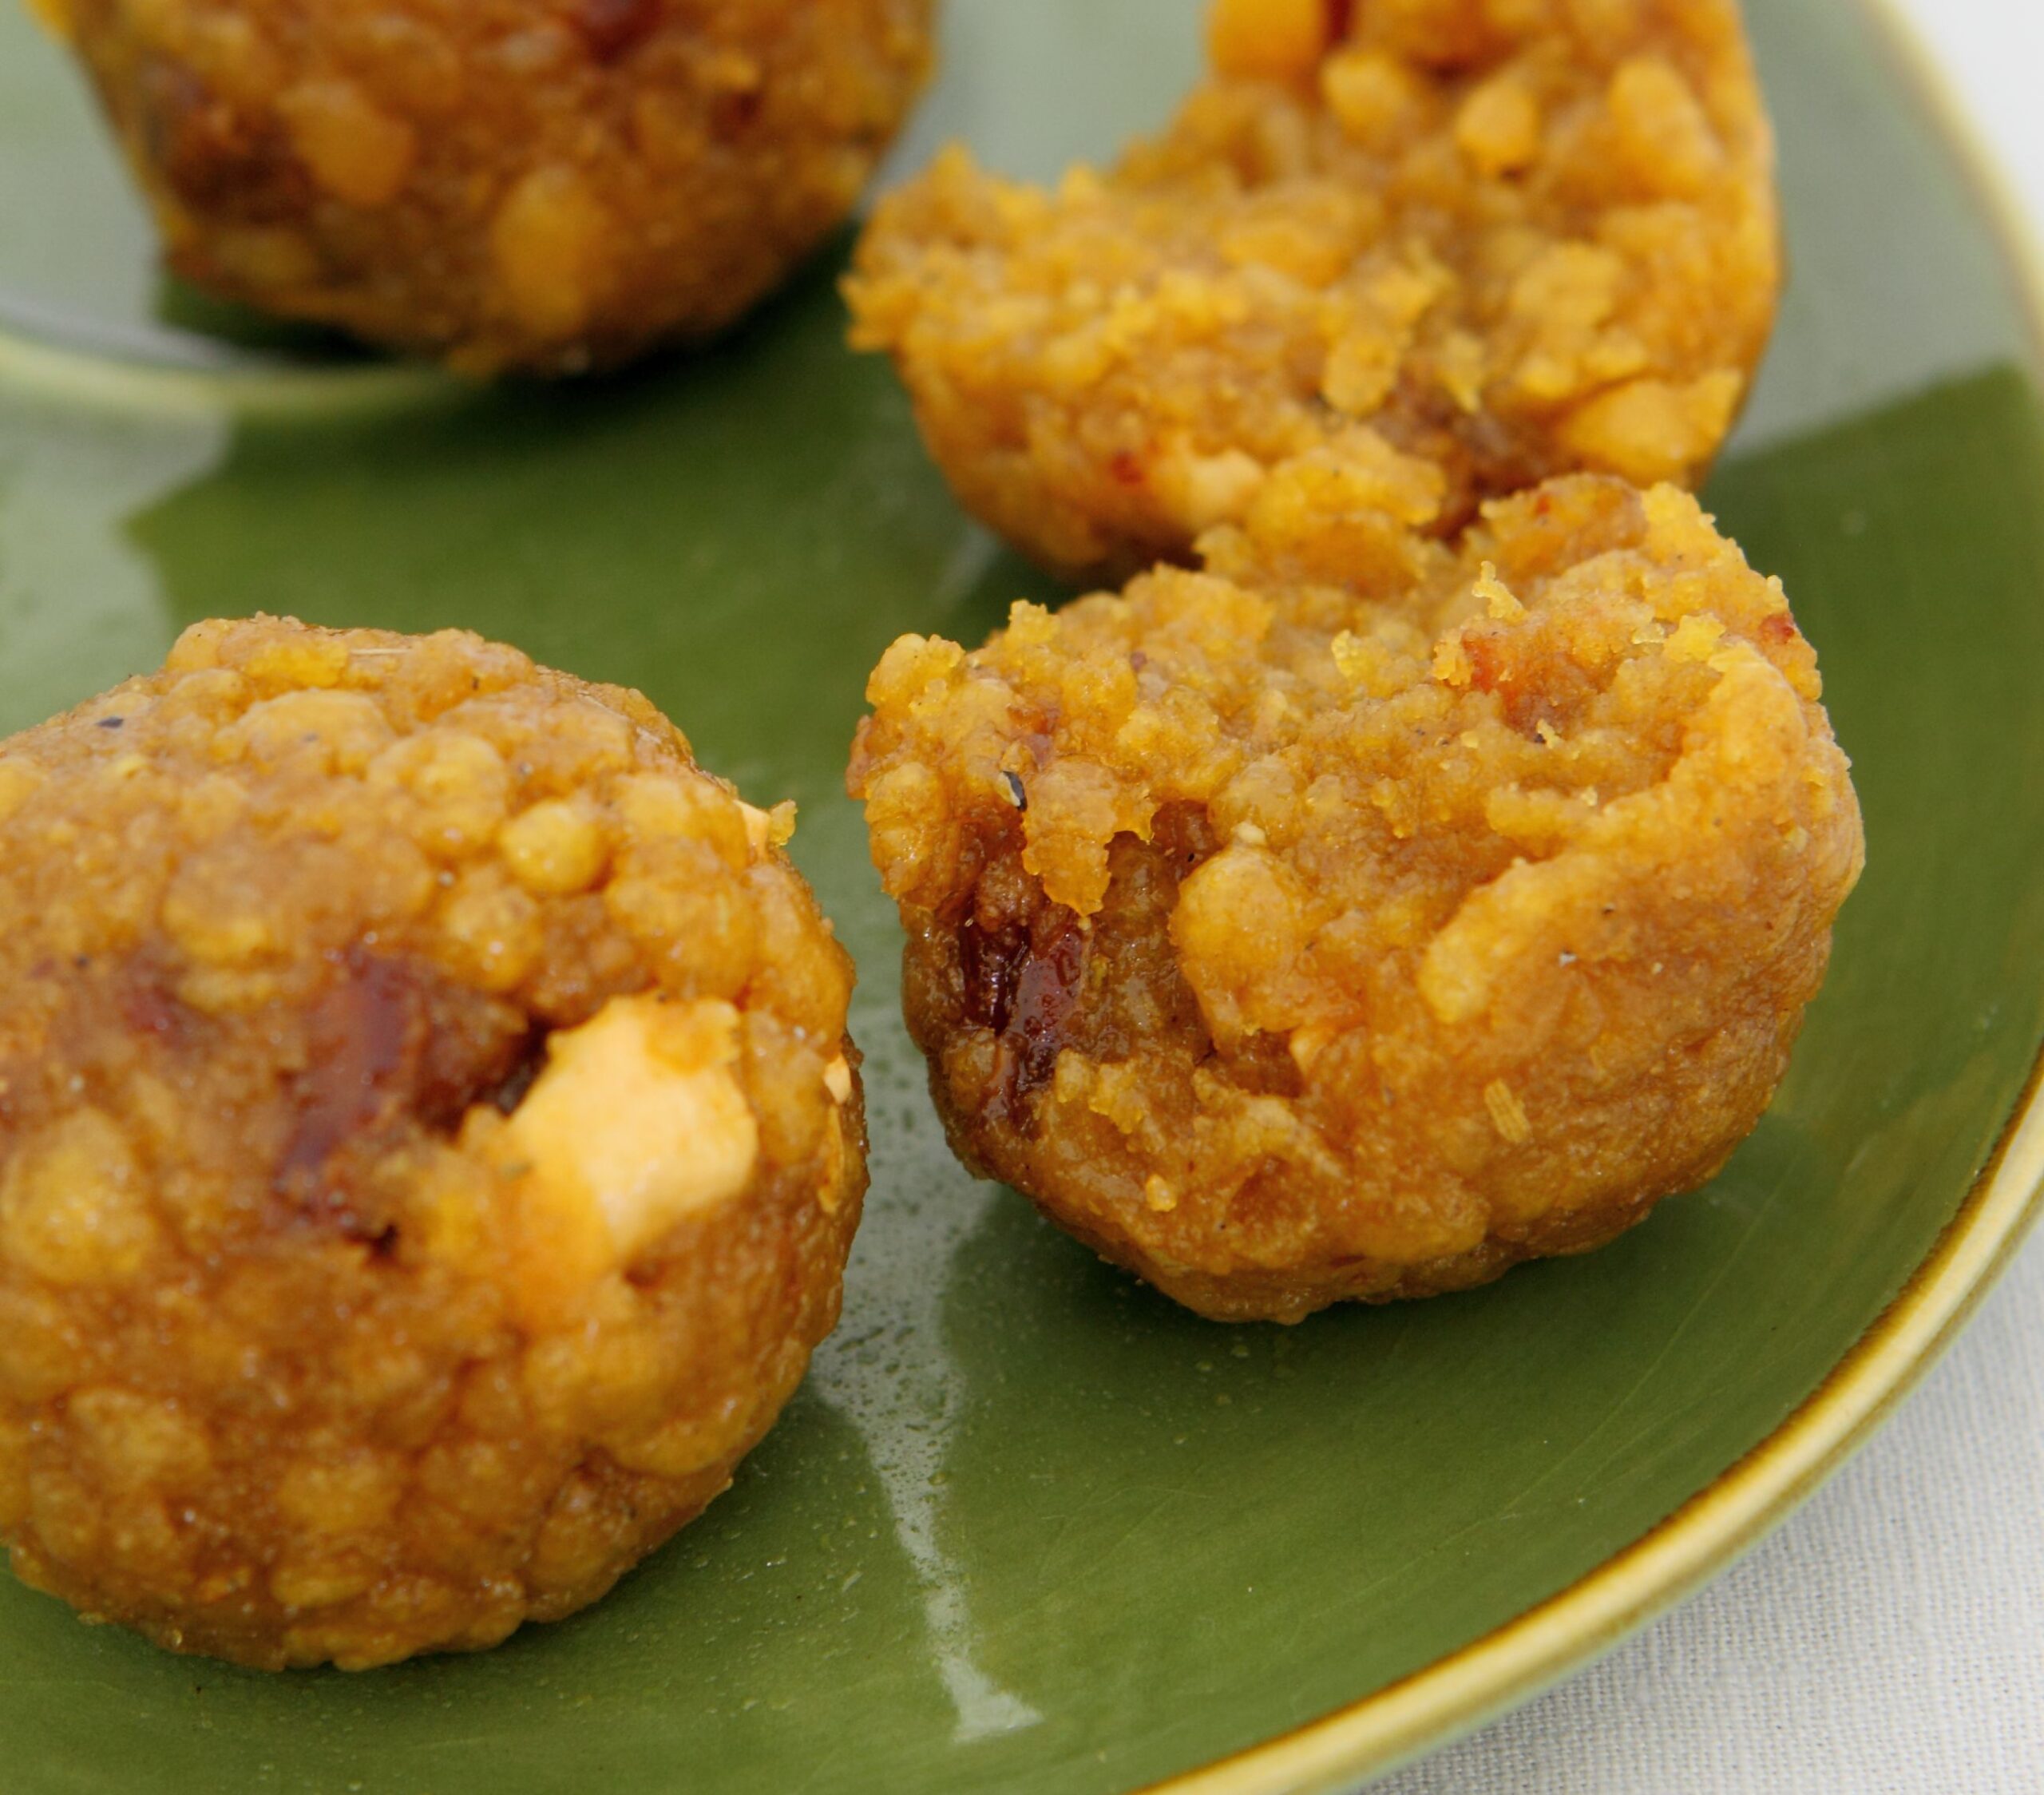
[1373,0,2044,1795]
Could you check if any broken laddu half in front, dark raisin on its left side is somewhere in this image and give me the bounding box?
[850,474,1864,1321]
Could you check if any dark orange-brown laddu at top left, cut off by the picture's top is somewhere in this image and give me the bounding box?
[37,0,930,374]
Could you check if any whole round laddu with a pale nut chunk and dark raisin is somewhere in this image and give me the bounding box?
[0,620,865,1668]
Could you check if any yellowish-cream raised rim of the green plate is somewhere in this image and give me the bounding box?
[1131,0,2044,1795]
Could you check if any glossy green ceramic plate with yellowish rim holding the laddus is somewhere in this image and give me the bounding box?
[0,0,2044,1795]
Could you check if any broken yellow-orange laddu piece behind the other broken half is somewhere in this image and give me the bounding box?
[848,0,1781,579]
